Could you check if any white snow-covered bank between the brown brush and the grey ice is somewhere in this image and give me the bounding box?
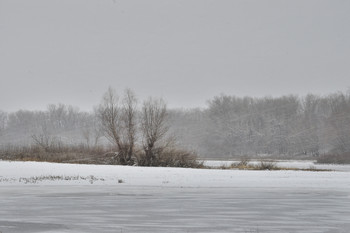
[0,161,350,190]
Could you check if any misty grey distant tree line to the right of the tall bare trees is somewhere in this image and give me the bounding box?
[167,92,350,158]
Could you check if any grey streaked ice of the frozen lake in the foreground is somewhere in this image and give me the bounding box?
[0,185,350,233]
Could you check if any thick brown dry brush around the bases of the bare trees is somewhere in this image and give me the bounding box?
[0,144,203,168]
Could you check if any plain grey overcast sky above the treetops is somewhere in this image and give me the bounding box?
[0,0,350,111]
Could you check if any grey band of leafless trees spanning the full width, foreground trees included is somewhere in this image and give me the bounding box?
[0,91,350,163]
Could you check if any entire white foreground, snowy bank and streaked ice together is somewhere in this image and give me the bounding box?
[0,161,350,233]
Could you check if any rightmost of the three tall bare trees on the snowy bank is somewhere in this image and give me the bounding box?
[139,98,169,166]
